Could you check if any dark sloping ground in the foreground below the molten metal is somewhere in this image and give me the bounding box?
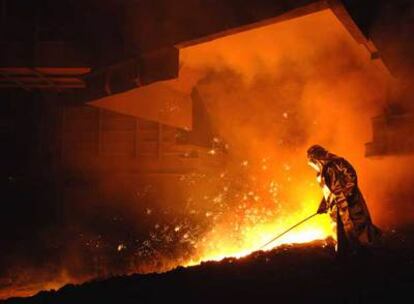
[0,228,414,304]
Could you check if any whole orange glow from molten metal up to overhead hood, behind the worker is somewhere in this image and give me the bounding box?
[0,10,402,298]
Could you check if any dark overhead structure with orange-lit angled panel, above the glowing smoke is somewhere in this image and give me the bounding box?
[0,0,414,154]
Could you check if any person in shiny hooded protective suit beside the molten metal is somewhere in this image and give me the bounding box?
[308,145,381,256]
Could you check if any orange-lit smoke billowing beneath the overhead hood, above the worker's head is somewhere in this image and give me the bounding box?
[181,11,387,208]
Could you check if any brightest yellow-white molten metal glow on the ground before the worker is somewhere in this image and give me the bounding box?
[187,171,333,265]
